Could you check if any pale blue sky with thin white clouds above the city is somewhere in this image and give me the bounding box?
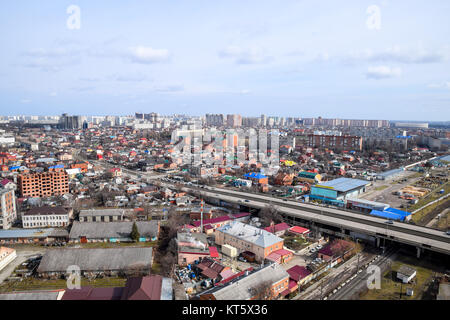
[0,0,450,121]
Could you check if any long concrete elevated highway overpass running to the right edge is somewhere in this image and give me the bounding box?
[178,185,450,256]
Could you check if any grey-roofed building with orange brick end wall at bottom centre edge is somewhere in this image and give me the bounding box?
[200,263,289,300]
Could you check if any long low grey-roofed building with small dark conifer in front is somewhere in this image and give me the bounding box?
[69,220,160,243]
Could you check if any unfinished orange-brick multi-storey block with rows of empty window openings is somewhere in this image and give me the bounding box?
[17,170,69,197]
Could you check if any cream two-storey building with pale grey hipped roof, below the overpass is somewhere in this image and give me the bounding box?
[216,221,284,262]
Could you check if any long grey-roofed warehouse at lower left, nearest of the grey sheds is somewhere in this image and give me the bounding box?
[37,247,153,278]
